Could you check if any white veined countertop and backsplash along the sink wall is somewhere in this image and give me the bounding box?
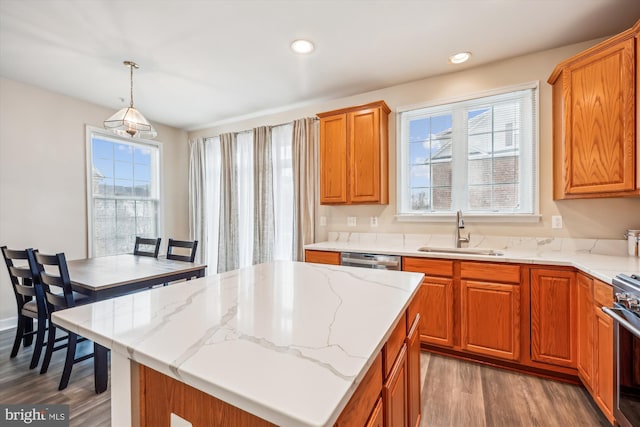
[305,232,640,284]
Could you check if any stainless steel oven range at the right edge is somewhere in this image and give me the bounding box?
[602,274,640,427]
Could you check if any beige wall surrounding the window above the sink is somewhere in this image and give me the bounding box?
[189,41,640,241]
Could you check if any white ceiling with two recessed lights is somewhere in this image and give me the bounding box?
[0,0,640,130]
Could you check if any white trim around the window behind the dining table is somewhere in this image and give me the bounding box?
[85,125,164,258]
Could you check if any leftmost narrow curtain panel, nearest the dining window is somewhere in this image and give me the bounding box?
[189,139,208,263]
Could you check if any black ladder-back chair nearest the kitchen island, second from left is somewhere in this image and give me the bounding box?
[35,252,100,390]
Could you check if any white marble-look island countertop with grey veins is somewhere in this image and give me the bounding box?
[53,262,422,426]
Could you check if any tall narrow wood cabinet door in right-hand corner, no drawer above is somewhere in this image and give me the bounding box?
[576,273,595,390]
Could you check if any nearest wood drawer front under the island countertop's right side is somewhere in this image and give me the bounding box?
[334,353,382,427]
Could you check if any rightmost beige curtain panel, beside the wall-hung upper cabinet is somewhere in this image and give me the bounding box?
[292,118,318,261]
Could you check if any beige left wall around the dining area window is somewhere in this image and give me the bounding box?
[0,78,189,328]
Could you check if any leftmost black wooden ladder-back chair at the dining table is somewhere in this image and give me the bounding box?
[0,246,48,369]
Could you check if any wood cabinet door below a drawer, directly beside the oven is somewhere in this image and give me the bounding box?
[594,306,613,421]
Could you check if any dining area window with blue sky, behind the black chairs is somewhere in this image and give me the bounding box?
[87,127,161,257]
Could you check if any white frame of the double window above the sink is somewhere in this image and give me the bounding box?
[395,81,541,223]
